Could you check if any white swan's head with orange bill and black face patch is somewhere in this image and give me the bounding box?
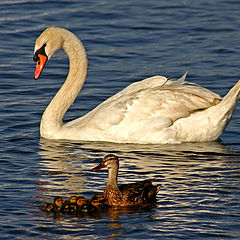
[33,27,67,79]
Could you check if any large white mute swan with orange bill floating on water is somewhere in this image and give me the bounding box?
[34,27,240,144]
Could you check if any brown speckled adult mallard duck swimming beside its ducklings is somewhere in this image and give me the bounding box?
[92,154,160,207]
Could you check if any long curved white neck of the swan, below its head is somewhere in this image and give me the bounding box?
[40,32,87,138]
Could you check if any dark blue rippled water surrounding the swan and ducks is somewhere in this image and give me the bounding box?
[0,0,240,239]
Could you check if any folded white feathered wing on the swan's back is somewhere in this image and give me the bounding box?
[69,75,221,131]
